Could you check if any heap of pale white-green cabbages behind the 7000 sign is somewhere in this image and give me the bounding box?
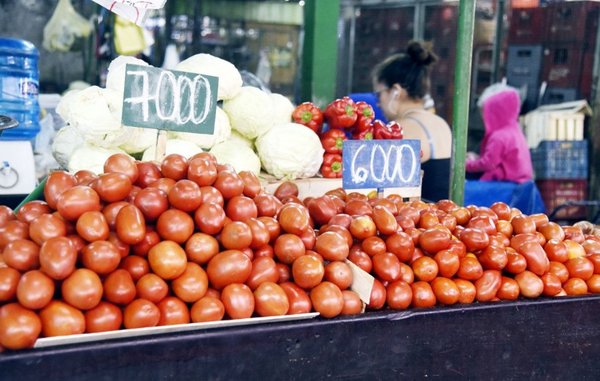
[52,54,323,179]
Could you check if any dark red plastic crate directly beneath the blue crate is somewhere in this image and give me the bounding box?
[536,179,588,220]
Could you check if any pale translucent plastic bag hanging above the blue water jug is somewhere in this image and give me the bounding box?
[43,0,92,52]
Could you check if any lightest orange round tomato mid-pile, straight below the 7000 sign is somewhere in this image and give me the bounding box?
[148,241,187,279]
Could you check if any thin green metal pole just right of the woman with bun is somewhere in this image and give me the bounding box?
[450,0,475,205]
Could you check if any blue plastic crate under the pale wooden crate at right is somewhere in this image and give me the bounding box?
[531,140,588,180]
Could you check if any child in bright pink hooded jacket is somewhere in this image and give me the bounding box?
[465,85,533,183]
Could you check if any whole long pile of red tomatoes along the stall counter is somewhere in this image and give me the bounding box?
[0,153,600,350]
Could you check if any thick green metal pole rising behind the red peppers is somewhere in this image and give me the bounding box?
[301,0,340,107]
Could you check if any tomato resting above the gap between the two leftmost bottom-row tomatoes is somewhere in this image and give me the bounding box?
[17,270,54,310]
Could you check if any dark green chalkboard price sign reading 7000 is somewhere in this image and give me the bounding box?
[122,64,219,135]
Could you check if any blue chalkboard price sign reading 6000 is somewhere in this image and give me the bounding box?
[342,139,421,189]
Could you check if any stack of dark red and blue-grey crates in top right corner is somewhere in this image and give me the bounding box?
[506,1,600,107]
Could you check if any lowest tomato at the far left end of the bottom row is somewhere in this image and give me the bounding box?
[0,303,42,350]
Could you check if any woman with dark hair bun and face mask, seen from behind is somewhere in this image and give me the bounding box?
[373,41,452,201]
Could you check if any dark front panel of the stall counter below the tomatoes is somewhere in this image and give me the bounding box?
[0,295,600,380]
